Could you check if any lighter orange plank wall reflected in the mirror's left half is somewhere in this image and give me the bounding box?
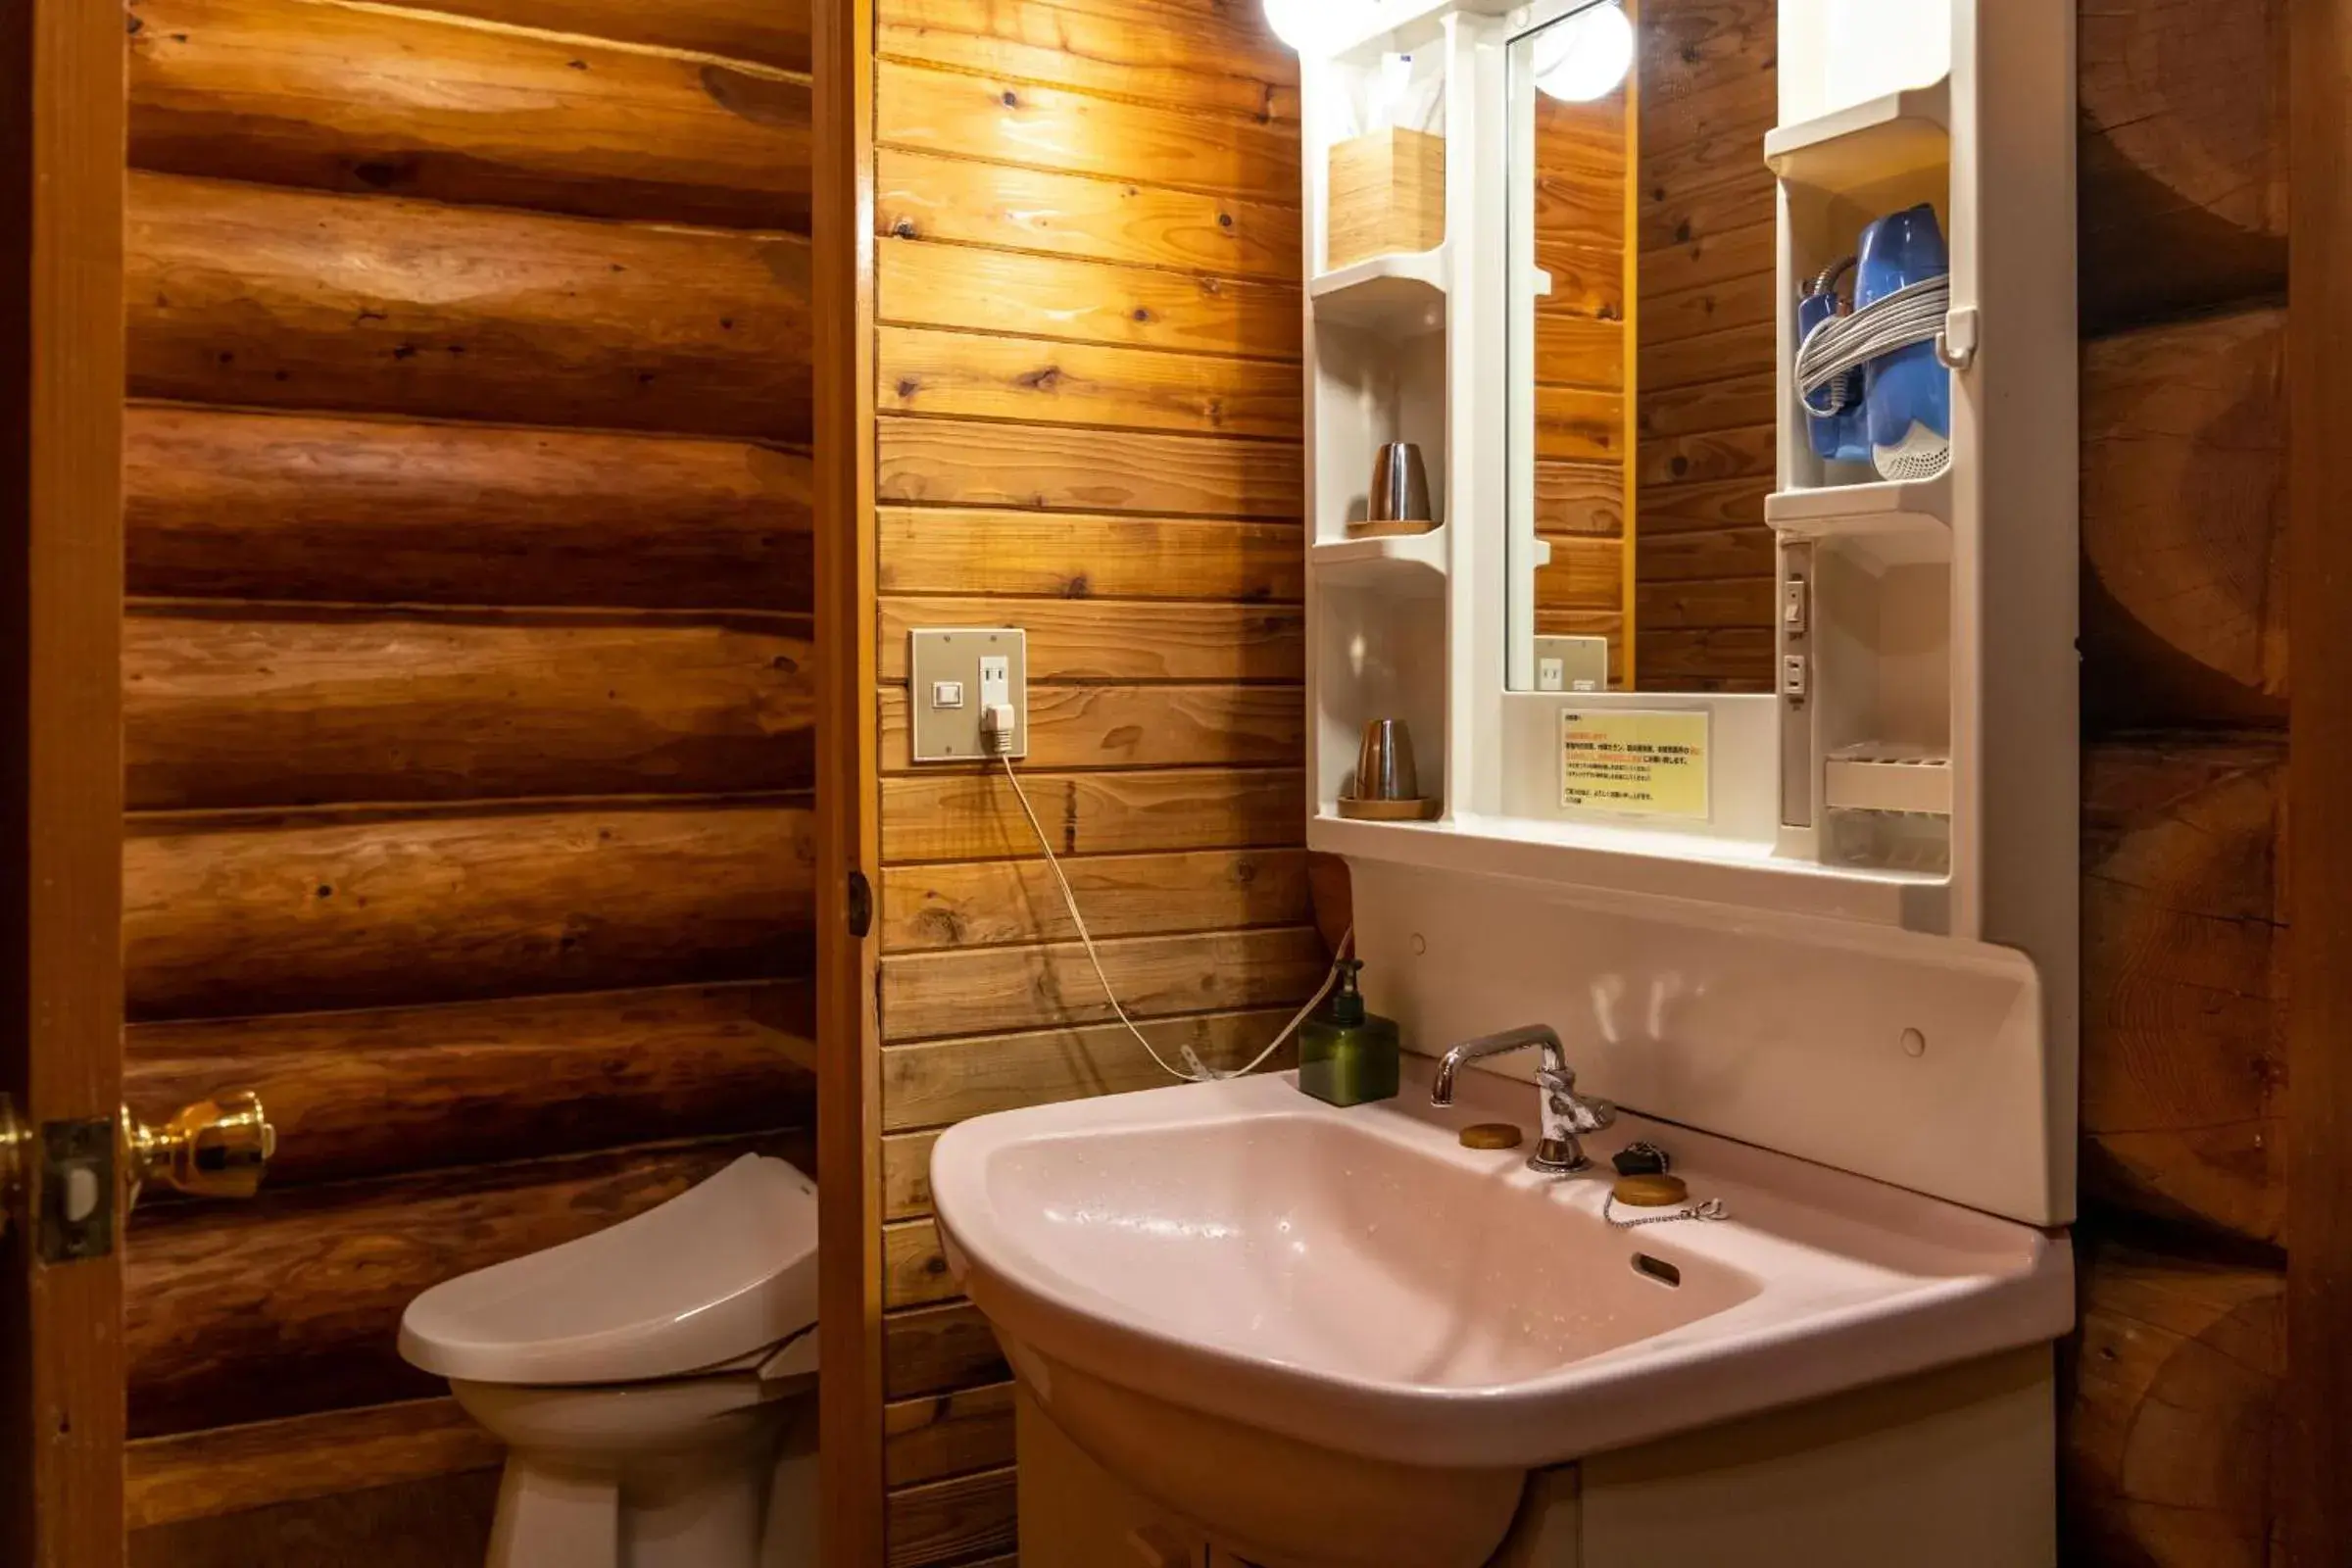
[1534,87,1640,686]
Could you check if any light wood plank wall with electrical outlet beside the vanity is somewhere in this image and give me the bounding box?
[875,0,1327,1568]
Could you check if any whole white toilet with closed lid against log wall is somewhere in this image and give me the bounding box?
[400,1154,816,1568]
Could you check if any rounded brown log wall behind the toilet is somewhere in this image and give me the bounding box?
[122,0,816,1568]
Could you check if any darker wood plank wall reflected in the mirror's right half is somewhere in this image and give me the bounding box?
[1635,0,1778,691]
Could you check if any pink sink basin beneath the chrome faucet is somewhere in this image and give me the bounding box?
[931,1057,2072,1568]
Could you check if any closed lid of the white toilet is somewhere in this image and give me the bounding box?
[400,1154,816,1385]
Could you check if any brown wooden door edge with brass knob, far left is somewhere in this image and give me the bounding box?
[0,0,122,1568]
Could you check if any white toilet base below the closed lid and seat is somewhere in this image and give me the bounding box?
[452,1373,816,1568]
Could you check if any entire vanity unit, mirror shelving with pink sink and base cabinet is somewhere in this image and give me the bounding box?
[934,0,2080,1568]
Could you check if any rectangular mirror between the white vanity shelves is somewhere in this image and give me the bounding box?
[1505,0,1778,691]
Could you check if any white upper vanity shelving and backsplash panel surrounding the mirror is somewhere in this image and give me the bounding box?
[1303,0,2080,1225]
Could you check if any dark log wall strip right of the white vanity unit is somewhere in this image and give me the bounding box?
[2065,0,2293,1568]
